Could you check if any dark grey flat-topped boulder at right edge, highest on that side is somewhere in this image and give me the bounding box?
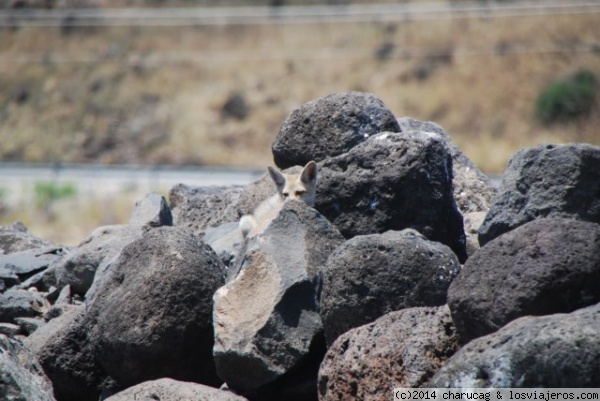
[479,143,600,245]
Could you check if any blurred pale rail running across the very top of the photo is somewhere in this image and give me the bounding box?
[0,0,600,27]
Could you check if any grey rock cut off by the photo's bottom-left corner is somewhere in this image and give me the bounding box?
[0,334,55,401]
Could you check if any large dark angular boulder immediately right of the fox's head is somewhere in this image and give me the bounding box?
[315,132,466,262]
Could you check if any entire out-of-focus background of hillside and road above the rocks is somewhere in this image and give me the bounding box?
[0,0,600,245]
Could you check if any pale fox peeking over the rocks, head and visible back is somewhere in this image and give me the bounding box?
[240,160,318,239]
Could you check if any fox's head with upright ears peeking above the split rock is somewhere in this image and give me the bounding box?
[268,161,317,206]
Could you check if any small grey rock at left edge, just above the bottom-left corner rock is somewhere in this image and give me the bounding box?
[0,288,50,323]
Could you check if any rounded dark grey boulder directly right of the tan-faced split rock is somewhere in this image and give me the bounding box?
[321,230,460,345]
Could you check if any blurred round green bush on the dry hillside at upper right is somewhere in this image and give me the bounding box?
[535,70,598,124]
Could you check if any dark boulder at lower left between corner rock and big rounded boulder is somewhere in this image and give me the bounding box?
[24,305,106,401]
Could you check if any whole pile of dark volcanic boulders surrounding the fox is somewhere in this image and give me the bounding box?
[0,92,600,401]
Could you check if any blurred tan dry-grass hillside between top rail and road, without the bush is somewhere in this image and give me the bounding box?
[0,10,600,173]
